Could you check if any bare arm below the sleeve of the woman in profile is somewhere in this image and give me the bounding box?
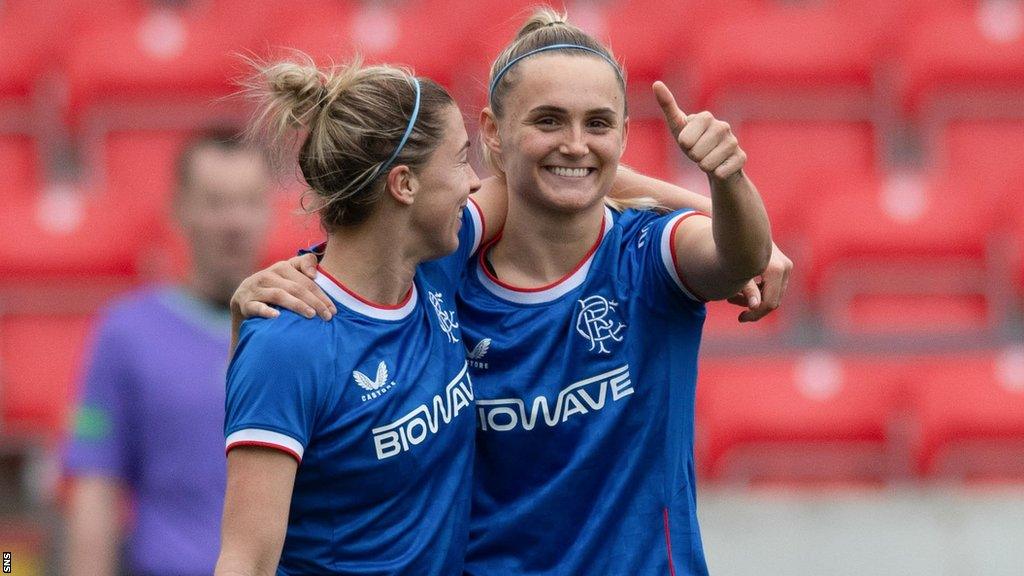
[215,446,298,576]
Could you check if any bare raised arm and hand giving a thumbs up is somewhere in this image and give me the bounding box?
[653,82,772,300]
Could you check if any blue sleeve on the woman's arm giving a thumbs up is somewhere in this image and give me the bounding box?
[626,210,708,310]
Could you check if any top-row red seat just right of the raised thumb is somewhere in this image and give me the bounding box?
[693,3,880,117]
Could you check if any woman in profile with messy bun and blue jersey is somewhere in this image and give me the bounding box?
[217,54,482,575]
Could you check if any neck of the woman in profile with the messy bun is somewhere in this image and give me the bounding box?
[321,210,425,305]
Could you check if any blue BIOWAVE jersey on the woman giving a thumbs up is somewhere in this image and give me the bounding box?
[459,206,707,576]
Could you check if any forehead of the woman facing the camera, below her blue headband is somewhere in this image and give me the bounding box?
[508,52,625,111]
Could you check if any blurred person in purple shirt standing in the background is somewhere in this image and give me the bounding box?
[63,130,271,576]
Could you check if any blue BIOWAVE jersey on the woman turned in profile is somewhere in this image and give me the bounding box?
[224,207,481,575]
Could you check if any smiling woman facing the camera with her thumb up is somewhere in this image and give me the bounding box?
[459,10,771,575]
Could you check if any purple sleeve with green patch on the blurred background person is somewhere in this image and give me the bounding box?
[63,313,136,481]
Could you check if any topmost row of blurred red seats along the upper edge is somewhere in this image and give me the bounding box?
[0,0,1024,120]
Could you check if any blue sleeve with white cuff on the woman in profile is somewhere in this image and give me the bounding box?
[224,315,333,463]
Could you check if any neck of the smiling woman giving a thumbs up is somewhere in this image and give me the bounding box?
[489,199,604,288]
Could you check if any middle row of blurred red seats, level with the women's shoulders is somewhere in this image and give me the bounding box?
[0,114,1024,332]
